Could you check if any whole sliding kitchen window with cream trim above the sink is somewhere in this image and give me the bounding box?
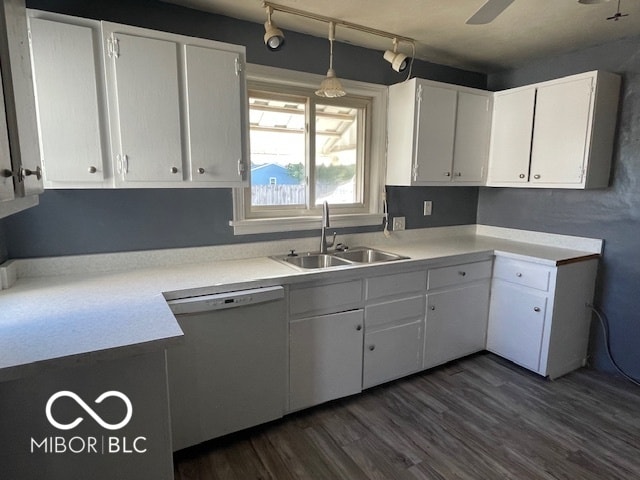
[230,66,386,234]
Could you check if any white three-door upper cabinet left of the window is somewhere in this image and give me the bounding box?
[29,10,249,188]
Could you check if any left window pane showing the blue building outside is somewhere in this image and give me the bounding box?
[249,95,307,207]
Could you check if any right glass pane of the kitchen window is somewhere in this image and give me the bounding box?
[314,104,363,205]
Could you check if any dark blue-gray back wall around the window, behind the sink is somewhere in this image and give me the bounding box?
[0,0,486,260]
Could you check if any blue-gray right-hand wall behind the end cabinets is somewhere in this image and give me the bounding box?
[478,35,640,377]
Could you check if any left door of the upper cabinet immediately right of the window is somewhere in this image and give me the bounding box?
[414,85,457,184]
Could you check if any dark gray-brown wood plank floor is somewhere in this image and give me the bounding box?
[174,353,640,480]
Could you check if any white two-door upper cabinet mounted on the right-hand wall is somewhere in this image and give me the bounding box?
[487,71,620,189]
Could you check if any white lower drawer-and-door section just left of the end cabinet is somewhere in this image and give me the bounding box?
[423,260,491,368]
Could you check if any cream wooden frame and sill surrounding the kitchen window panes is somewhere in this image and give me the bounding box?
[229,64,388,235]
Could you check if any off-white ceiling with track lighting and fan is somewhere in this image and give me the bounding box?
[161,0,640,73]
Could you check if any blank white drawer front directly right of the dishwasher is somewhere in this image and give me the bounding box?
[289,280,362,316]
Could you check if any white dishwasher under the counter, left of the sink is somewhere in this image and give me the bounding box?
[167,286,287,451]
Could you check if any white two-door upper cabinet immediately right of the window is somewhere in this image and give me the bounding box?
[386,78,492,186]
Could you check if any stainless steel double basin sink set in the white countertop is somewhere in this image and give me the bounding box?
[271,247,409,270]
